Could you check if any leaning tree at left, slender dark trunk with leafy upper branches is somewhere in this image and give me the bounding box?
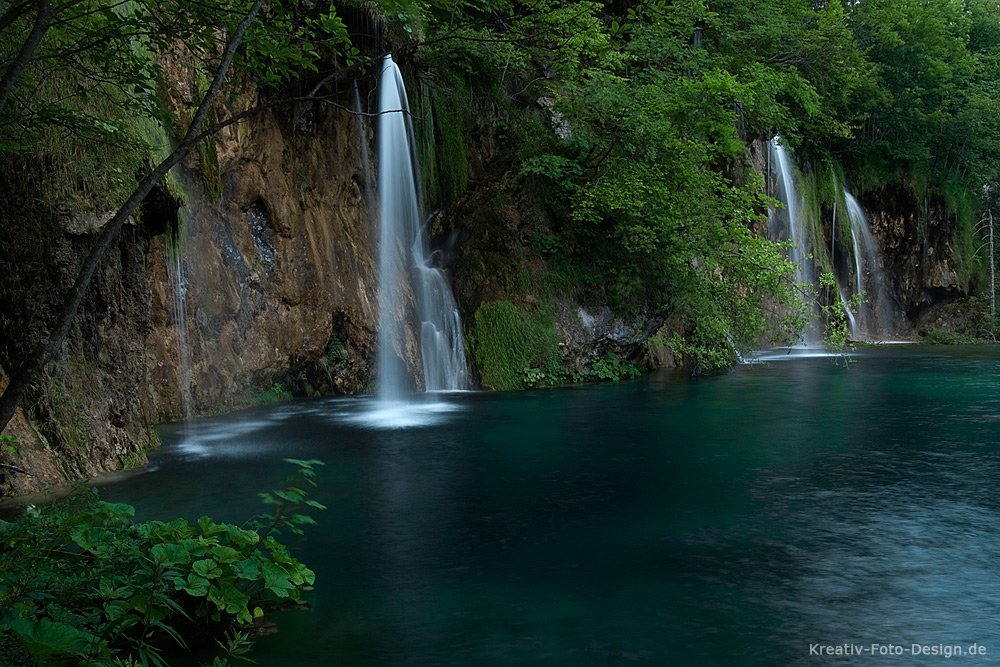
[0,0,356,430]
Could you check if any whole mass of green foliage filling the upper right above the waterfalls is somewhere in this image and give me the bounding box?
[416,0,1000,368]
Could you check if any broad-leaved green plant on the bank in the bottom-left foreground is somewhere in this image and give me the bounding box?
[0,459,324,665]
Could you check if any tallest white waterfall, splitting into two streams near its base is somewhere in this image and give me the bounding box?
[376,55,468,400]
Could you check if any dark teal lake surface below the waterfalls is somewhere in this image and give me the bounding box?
[106,346,1000,666]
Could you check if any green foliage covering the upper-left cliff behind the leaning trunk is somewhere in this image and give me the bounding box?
[0,0,356,210]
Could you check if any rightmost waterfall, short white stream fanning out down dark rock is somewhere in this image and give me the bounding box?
[844,188,903,339]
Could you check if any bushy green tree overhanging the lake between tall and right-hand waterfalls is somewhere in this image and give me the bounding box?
[432,1,815,370]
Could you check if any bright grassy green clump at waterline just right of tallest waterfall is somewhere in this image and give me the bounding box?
[468,301,560,390]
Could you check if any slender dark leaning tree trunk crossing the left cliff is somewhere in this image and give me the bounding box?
[0,0,264,432]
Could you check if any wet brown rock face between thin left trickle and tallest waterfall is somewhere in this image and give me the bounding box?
[146,73,386,417]
